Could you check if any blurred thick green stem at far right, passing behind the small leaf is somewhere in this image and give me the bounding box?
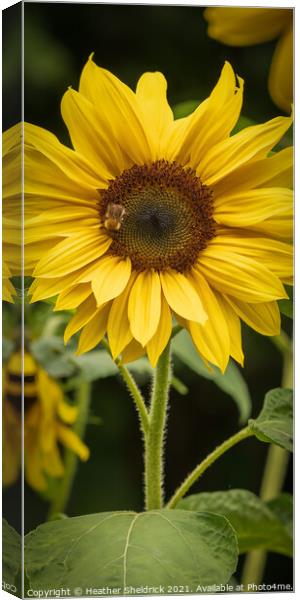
[242,332,293,592]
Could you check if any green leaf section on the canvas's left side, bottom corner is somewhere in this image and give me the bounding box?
[2,519,22,591]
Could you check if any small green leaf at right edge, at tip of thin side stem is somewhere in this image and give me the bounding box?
[249,388,293,452]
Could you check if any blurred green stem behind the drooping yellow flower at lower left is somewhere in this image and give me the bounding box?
[48,382,91,520]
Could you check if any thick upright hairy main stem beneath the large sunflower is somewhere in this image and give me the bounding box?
[145,342,171,510]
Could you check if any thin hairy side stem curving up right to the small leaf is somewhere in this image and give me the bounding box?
[167,426,253,508]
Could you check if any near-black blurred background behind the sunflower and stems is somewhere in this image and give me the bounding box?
[3,2,292,583]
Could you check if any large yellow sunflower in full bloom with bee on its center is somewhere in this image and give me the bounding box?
[14,58,293,371]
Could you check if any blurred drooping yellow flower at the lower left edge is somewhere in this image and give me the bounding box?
[3,352,89,492]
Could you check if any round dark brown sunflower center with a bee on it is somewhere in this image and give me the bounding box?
[100,160,216,272]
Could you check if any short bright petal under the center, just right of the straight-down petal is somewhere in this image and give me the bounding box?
[160,270,207,323]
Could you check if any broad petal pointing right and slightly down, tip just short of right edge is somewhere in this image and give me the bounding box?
[198,245,287,303]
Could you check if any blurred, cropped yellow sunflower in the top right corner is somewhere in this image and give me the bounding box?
[204,7,293,113]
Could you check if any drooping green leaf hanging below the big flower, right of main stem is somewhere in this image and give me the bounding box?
[172,330,251,423]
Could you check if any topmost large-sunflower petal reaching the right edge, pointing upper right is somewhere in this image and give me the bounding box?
[197,112,292,186]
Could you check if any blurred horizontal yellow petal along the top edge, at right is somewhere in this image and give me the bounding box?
[204,7,292,46]
